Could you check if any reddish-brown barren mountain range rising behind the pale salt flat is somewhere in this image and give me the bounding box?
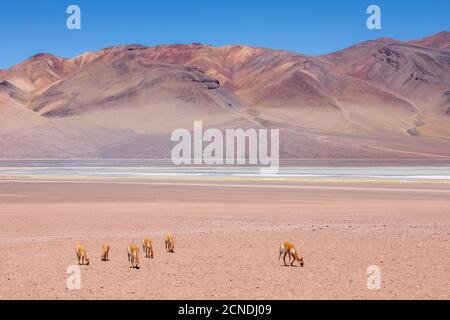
[0,32,450,159]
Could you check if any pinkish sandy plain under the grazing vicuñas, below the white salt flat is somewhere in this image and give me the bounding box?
[0,180,450,299]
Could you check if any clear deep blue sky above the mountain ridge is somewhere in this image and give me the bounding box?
[0,0,450,69]
